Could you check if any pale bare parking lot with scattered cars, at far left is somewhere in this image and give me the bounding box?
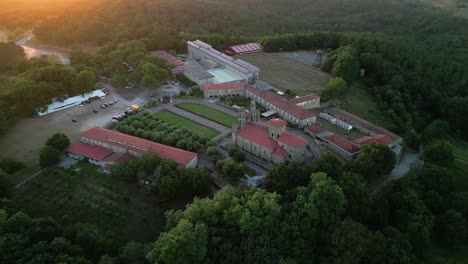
[0,93,141,163]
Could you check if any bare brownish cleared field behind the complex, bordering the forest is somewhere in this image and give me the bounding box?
[238,52,330,95]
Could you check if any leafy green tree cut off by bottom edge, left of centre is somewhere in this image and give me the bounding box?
[146,219,208,264]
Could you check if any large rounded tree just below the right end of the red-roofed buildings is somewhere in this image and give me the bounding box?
[350,144,396,180]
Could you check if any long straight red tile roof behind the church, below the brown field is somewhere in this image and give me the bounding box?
[246,85,315,120]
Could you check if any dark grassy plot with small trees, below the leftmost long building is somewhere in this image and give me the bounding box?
[12,161,191,242]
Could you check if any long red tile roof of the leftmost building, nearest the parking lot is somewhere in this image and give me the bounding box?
[81,127,197,166]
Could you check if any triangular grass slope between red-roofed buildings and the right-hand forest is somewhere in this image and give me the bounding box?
[335,82,395,130]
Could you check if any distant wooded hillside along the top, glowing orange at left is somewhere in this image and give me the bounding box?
[36,0,466,45]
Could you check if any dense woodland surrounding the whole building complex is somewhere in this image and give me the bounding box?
[0,0,468,264]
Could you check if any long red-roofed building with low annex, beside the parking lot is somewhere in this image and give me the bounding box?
[67,127,198,168]
